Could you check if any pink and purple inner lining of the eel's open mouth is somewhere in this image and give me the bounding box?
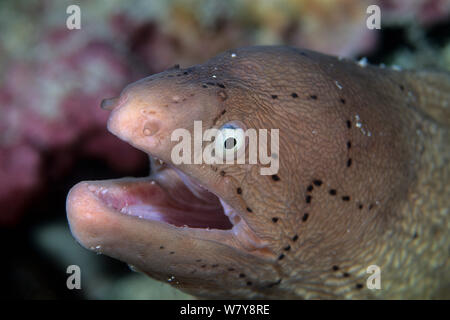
[85,158,241,230]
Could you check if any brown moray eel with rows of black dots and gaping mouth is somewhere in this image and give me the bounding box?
[67,46,450,299]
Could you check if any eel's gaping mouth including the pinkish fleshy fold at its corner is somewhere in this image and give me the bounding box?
[76,159,272,257]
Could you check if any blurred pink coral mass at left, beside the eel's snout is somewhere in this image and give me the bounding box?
[0,30,147,224]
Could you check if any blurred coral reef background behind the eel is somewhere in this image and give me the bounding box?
[0,0,450,299]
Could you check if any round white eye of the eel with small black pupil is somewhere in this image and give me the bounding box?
[214,121,245,159]
